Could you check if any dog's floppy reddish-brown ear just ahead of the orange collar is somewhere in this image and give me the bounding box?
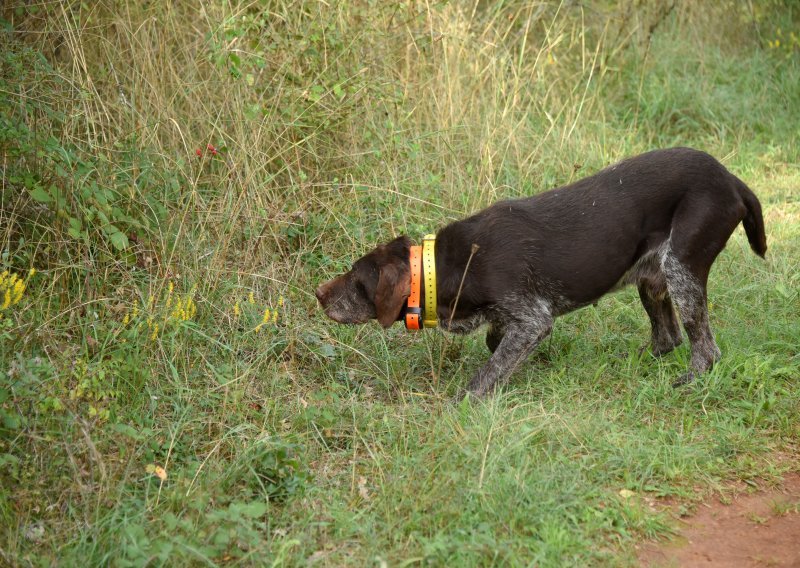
[375,237,411,328]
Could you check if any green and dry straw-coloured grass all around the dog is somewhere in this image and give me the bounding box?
[0,0,800,566]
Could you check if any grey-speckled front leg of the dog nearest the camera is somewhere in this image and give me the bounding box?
[469,310,553,397]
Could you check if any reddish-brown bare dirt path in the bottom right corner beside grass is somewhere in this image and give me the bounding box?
[638,474,800,568]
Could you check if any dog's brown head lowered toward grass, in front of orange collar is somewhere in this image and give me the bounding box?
[316,237,411,327]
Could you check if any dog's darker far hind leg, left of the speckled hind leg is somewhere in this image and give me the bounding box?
[637,271,683,357]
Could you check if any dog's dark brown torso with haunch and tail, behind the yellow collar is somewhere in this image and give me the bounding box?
[437,148,766,311]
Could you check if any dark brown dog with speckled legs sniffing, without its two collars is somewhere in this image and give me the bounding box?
[316,148,767,397]
